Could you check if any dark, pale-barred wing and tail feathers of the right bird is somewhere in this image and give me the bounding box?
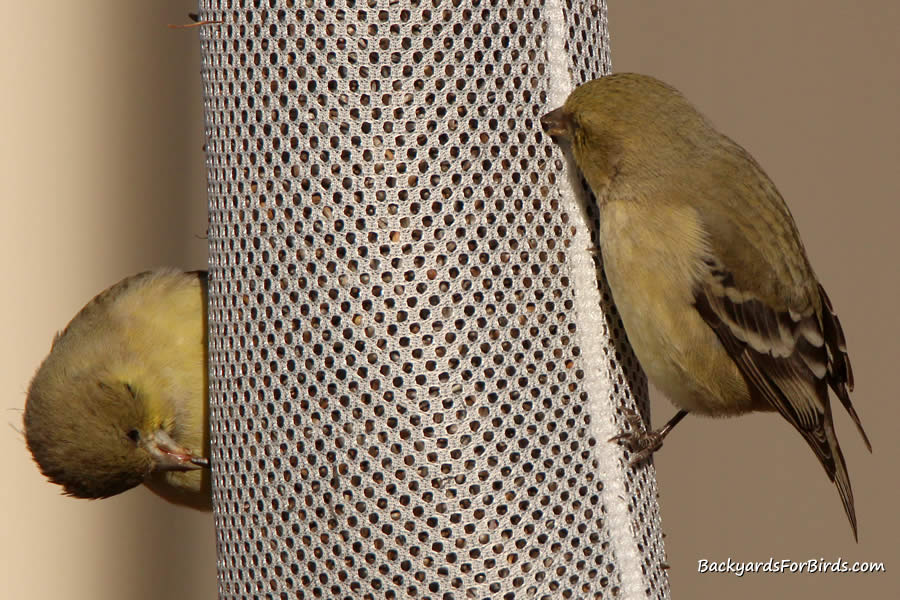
[694,248,871,536]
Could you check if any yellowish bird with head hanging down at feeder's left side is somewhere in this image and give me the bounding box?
[24,269,212,510]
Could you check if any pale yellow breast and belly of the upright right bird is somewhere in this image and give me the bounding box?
[600,200,760,416]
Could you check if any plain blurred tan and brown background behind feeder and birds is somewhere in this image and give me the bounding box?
[0,0,900,600]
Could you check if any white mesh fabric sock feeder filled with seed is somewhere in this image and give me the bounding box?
[201,0,668,600]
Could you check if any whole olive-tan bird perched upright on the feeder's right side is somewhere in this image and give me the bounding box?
[541,73,872,537]
